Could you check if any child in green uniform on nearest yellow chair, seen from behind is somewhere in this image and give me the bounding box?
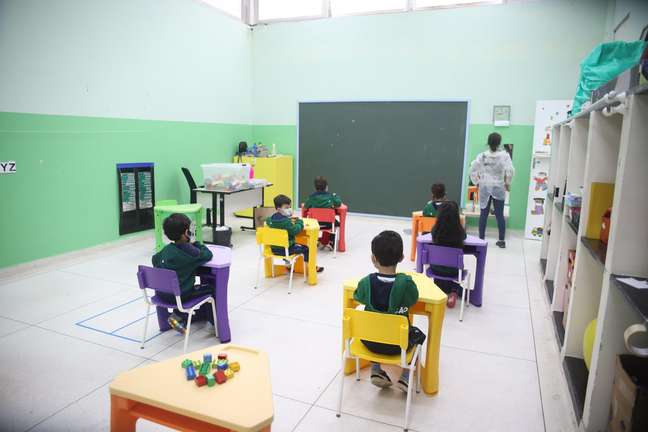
[353,231,420,393]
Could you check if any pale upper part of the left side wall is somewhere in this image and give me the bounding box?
[0,0,251,123]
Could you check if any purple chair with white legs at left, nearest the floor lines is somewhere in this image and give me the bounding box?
[137,265,218,352]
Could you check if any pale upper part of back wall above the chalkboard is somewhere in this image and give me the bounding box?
[252,0,612,124]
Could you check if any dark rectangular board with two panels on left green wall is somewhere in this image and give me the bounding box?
[117,162,155,235]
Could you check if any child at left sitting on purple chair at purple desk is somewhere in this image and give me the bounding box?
[151,213,213,333]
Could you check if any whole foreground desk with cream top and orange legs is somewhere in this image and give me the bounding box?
[110,345,274,432]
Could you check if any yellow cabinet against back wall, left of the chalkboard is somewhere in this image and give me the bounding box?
[233,155,296,218]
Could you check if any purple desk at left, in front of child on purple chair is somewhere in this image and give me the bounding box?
[156,245,232,343]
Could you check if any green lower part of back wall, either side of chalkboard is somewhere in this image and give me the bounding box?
[252,124,533,229]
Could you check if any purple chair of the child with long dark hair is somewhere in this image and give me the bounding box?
[423,244,472,321]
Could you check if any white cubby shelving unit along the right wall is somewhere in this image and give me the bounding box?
[540,86,648,432]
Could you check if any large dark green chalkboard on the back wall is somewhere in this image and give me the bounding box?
[298,101,468,216]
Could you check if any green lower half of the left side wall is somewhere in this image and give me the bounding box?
[0,113,251,267]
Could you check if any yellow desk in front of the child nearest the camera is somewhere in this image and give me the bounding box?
[342,272,448,394]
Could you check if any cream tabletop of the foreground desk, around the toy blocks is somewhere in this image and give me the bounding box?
[110,345,274,432]
